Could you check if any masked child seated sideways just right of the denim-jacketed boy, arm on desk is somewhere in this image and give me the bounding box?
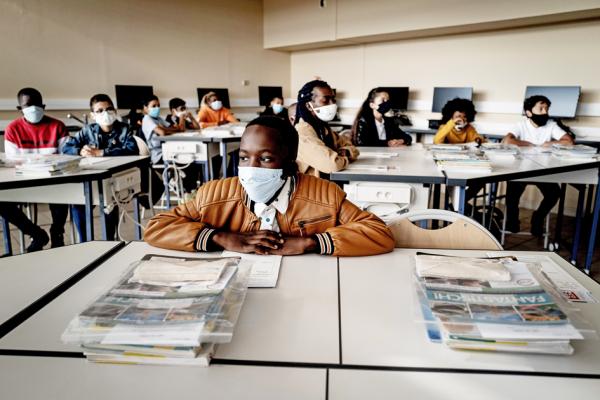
[142,95,199,193]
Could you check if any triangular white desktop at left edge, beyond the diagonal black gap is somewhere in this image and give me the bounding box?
[0,242,120,335]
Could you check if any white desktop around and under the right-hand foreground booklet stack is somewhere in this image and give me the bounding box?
[340,249,600,375]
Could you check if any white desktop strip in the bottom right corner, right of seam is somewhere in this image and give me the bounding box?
[329,370,600,400]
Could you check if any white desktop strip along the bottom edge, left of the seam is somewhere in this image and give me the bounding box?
[0,356,326,400]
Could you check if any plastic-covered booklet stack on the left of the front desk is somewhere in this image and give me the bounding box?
[62,255,251,366]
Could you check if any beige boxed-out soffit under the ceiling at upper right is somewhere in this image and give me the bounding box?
[264,0,600,50]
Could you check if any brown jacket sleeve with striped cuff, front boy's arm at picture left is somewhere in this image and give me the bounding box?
[144,186,215,251]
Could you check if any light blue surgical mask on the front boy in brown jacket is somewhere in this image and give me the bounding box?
[238,167,285,203]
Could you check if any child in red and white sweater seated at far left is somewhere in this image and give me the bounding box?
[0,88,69,252]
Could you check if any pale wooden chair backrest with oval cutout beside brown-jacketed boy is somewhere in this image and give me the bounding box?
[389,209,503,250]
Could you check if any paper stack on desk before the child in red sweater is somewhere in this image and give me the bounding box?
[15,154,81,177]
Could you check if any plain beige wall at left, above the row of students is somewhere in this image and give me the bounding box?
[0,0,290,119]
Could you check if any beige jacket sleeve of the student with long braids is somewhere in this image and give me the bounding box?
[296,123,350,174]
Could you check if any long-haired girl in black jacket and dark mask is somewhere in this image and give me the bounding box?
[352,88,412,147]
